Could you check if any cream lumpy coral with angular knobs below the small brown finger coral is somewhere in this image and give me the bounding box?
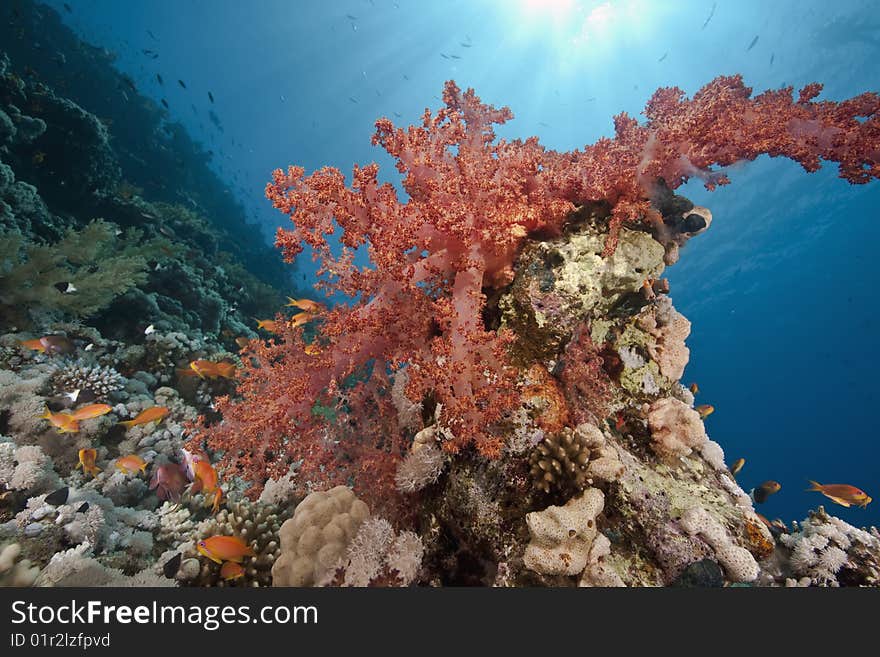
[523,488,605,575]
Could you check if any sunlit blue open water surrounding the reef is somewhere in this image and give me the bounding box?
[48,0,880,526]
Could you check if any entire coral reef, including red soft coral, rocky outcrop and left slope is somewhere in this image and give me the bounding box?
[0,9,880,587]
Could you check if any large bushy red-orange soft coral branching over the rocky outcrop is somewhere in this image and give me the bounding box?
[194,76,880,502]
